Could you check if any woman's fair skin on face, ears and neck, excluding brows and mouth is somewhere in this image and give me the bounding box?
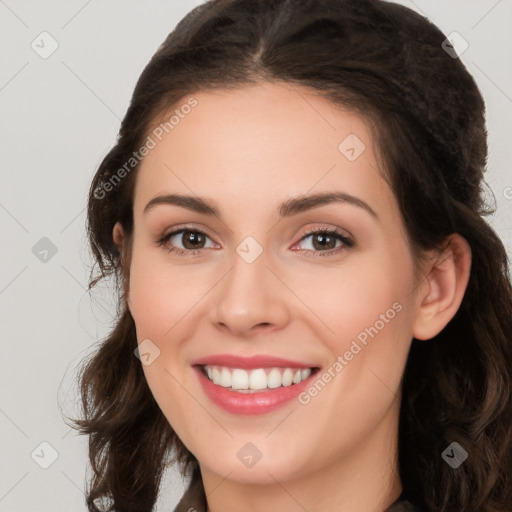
[113,82,471,512]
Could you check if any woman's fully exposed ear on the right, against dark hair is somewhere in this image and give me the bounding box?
[413,234,471,340]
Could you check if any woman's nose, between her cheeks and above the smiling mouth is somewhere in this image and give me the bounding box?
[211,246,291,337]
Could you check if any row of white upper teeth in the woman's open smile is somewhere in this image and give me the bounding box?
[204,365,311,393]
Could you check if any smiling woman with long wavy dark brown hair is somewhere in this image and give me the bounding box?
[67,0,512,512]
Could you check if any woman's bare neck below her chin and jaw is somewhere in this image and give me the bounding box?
[201,401,402,512]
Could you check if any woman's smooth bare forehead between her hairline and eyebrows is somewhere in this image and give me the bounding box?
[134,82,392,220]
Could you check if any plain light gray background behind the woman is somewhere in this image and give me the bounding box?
[0,0,512,512]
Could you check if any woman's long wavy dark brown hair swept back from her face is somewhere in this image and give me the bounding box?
[66,0,512,512]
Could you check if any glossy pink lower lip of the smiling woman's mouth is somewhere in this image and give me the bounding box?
[193,366,318,416]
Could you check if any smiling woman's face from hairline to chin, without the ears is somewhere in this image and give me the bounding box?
[123,83,424,483]
